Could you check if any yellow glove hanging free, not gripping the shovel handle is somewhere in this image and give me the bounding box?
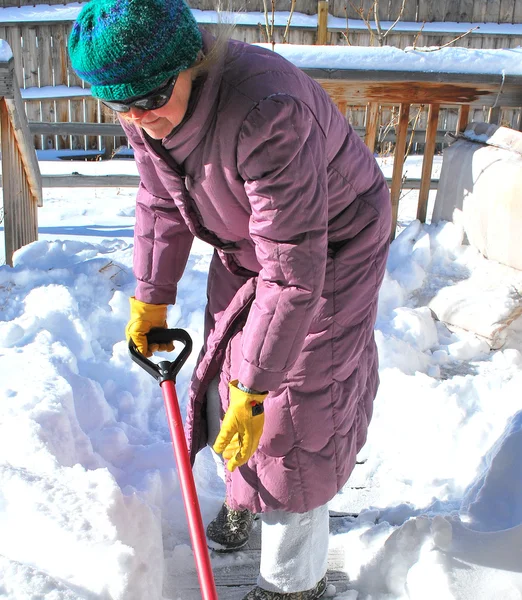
[213,379,267,471]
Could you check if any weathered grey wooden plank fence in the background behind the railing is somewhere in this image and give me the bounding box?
[0,0,522,158]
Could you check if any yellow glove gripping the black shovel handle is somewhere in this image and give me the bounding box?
[125,296,174,356]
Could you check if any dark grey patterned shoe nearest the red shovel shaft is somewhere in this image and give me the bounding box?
[207,502,255,552]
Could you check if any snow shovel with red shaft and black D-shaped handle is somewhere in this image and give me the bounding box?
[129,329,218,600]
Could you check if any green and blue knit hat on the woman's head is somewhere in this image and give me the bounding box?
[69,0,202,100]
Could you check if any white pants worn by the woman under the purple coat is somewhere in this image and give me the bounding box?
[207,377,329,594]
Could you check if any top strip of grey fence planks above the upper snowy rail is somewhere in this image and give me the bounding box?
[5,0,522,23]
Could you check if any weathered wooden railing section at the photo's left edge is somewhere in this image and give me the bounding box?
[0,50,42,265]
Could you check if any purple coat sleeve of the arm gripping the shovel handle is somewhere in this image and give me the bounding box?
[120,119,193,304]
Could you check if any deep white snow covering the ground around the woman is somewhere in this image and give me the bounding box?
[0,159,522,600]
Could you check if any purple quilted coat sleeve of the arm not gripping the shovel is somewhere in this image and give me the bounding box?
[238,94,328,390]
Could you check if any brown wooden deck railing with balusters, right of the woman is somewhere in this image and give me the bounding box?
[304,63,522,237]
